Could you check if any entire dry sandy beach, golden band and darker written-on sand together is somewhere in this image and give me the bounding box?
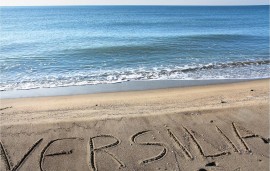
[0,79,269,171]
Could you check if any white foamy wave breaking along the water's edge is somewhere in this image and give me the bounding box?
[0,60,270,91]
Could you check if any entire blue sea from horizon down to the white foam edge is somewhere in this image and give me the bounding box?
[0,6,270,91]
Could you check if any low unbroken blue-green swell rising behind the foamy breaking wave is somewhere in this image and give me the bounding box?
[61,34,269,56]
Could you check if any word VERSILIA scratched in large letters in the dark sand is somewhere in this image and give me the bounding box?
[0,122,269,171]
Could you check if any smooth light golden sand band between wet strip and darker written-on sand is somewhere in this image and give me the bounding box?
[1,79,270,125]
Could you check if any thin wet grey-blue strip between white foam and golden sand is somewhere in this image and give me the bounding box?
[0,78,269,99]
